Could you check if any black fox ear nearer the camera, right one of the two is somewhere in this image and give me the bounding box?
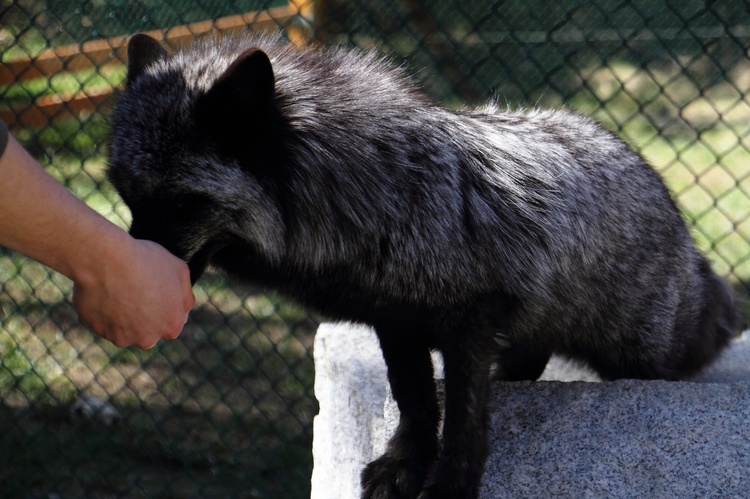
[196,48,276,138]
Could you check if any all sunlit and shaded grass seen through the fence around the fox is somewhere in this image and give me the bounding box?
[0,38,750,497]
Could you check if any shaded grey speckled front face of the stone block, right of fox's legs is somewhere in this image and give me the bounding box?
[481,380,750,498]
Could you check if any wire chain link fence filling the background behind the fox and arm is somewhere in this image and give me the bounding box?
[0,0,750,498]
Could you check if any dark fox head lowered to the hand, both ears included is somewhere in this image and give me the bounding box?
[108,34,284,282]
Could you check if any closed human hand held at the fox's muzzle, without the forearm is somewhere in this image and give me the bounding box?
[73,237,195,349]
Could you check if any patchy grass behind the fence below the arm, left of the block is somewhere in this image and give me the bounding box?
[0,270,317,498]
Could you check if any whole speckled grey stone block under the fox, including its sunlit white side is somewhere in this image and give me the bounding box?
[312,324,750,499]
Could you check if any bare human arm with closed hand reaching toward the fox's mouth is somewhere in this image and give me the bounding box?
[0,125,195,348]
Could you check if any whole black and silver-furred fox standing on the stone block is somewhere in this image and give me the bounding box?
[108,34,739,499]
